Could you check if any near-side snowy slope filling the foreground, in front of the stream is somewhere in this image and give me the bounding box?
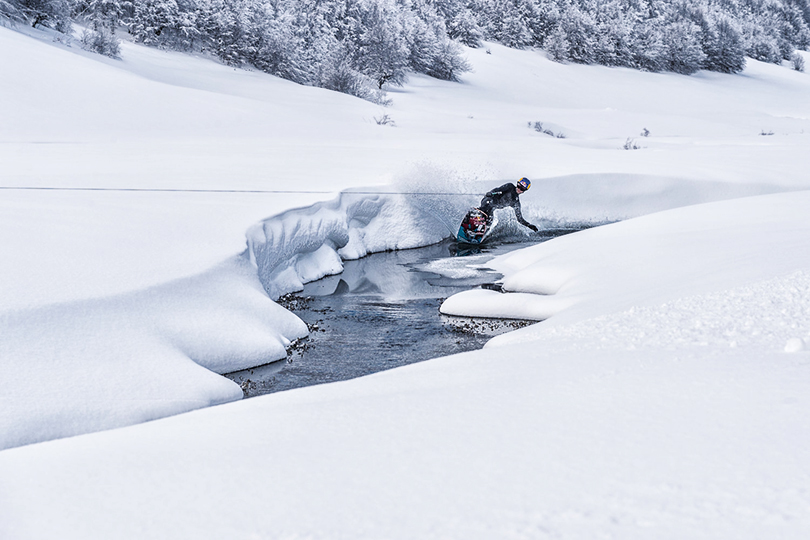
[0,192,810,539]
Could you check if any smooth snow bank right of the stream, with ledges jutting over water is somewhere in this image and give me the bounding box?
[441,191,810,338]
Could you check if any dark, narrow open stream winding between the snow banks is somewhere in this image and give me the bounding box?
[226,229,573,397]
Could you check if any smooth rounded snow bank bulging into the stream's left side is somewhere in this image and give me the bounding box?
[0,257,307,448]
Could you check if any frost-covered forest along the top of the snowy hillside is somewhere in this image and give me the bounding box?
[0,0,810,102]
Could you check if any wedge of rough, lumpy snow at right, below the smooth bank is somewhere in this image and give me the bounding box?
[498,267,810,355]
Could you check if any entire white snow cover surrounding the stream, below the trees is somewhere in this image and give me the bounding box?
[0,23,810,540]
